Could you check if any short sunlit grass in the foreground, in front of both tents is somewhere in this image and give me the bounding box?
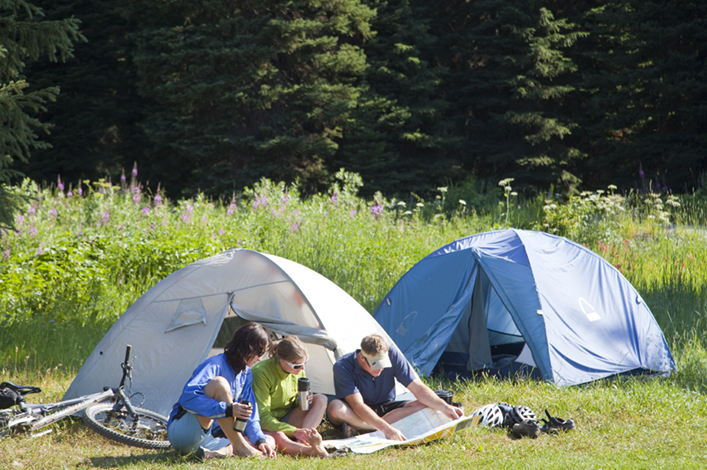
[0,373,707,469]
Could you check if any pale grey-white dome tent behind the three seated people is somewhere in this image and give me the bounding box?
[64,249,405,416]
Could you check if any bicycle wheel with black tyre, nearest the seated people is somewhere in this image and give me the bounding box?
[83,403,170,449]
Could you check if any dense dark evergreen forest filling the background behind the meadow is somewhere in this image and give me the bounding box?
[0,0,707,198]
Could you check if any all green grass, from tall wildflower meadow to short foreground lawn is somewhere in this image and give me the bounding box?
[0,175,707,470]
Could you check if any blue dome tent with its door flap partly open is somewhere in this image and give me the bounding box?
[374,229,676,386]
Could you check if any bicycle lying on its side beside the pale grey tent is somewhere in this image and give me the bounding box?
[0,345,170,449]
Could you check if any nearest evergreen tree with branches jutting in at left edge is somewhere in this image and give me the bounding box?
[0,0,84,228]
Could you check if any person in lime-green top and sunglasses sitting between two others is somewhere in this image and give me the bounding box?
[253,335,329,457]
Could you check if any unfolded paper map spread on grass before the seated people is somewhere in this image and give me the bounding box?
[322,408,480,454]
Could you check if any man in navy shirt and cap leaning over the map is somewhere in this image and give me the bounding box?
[327,334,464,441]
